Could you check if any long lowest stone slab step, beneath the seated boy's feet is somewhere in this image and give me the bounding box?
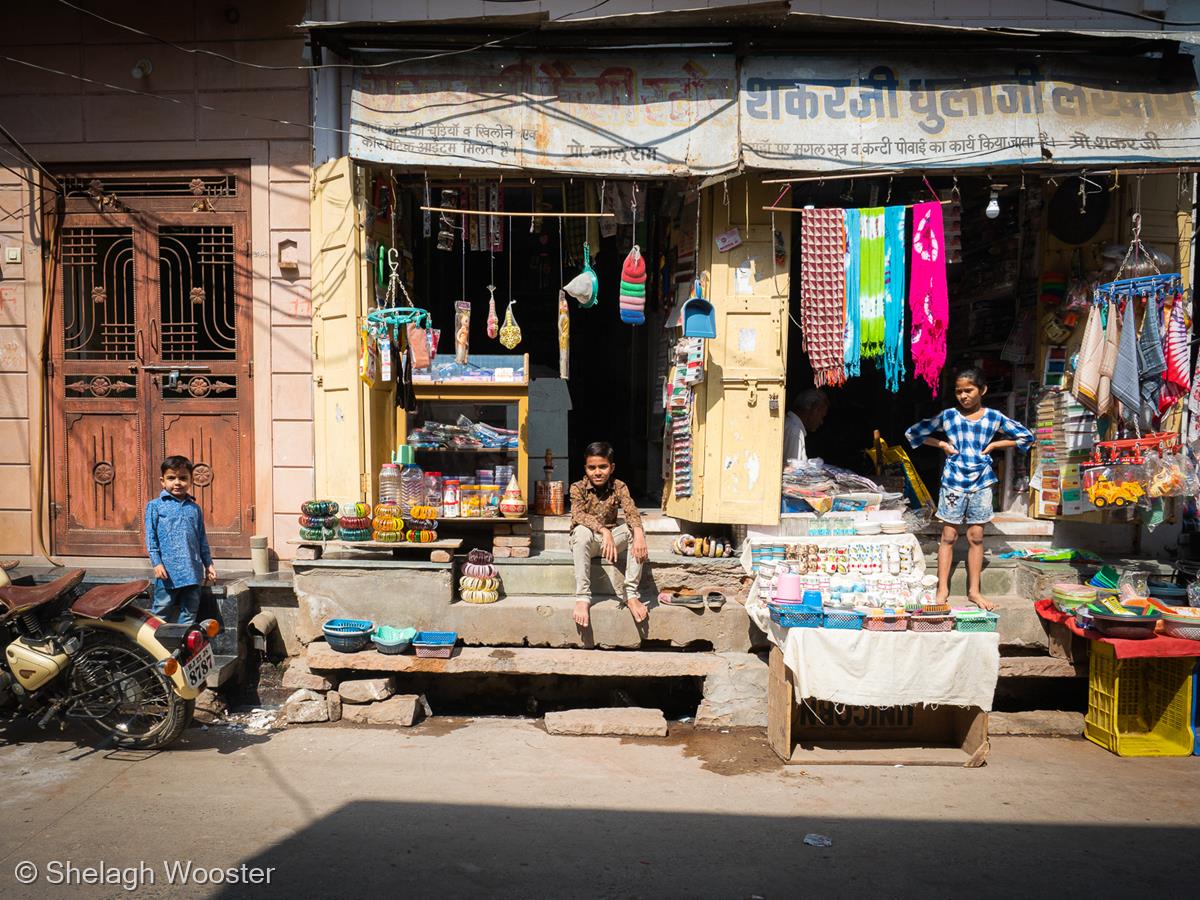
[305,641,727,676]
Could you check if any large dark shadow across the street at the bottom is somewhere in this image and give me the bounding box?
[217,801,1200,900]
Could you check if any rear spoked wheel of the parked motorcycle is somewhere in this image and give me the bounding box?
[68,632,196,750]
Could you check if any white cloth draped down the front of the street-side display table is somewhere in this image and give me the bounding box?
[746,602,1000,710]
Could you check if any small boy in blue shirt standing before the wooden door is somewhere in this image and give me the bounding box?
[145,456,217,625]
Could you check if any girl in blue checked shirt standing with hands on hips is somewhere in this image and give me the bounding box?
[905,368,1033,610]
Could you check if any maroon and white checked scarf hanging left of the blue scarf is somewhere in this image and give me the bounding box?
[800,209,846,388]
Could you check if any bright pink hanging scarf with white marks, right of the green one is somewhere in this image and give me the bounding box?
[908,200,950,397]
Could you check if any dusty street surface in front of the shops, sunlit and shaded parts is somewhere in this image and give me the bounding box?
[0,719,1200,899]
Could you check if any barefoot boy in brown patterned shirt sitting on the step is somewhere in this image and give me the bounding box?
[571,440,649,628]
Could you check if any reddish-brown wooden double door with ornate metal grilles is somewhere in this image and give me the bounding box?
[47,167,254,557]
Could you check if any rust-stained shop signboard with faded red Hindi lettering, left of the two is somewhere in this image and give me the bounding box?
[350,53,738,176]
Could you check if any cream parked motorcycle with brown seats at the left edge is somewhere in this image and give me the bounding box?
[0,569,221,750]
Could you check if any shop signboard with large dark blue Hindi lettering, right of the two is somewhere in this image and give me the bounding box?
[739,54,1200,172]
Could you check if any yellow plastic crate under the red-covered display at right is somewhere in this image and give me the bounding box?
[1084,641,1196,756]
